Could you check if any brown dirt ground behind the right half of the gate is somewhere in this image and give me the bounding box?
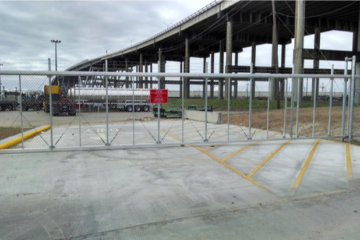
[223,107,360,143]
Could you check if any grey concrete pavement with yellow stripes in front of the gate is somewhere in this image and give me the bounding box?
[0,133,360,239]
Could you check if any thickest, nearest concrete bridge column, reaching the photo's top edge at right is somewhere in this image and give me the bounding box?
[292,0,305,101]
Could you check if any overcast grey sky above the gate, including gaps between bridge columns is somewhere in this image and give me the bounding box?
[0,0,352,92]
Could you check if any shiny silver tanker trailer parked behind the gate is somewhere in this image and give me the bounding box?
[68,87,152,112]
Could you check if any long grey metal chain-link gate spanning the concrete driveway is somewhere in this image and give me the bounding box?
[0,65,359,150]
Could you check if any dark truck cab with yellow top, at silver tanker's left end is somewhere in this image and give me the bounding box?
[44,85,76,116]
